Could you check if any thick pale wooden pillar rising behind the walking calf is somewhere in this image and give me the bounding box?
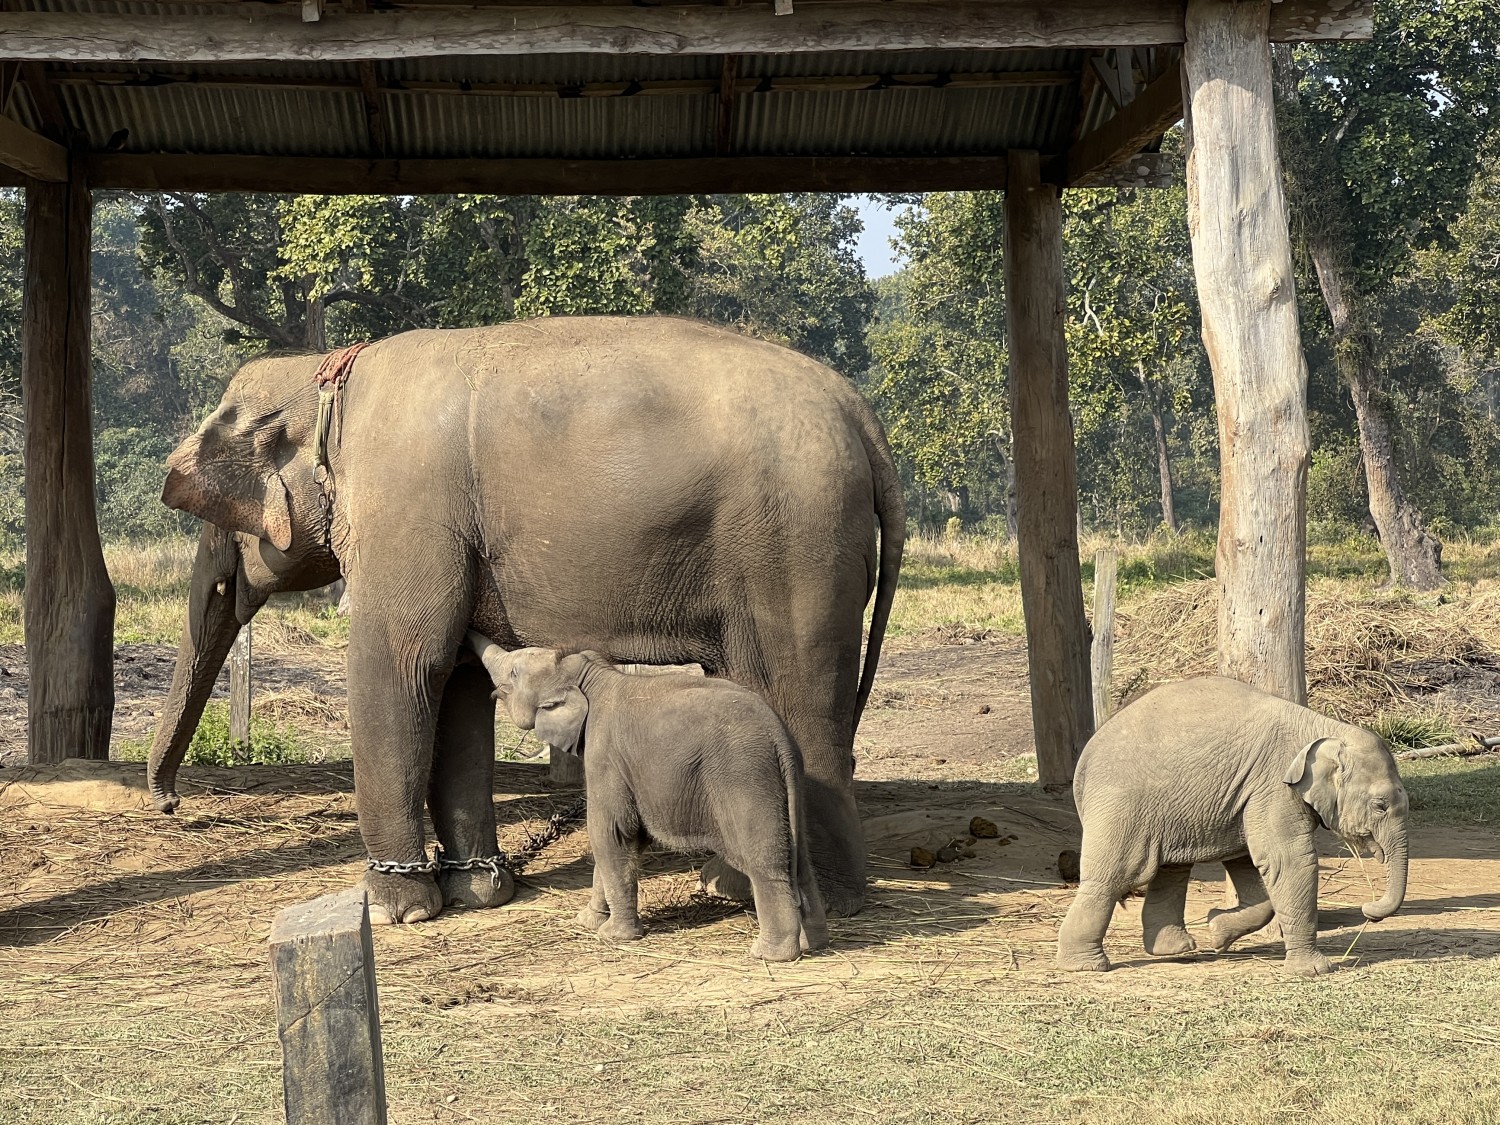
[1182,0,1308,704]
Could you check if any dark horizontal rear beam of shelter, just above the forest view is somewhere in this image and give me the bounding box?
[89,153,1007,195]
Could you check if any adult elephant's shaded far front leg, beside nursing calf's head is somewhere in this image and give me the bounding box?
[428,665,516,908]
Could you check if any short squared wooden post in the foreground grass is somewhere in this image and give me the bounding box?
[270,891,386,1125]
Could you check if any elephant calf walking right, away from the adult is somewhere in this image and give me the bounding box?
[1058,677,1407,977]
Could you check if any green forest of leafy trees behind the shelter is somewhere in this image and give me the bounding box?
[0,0,1500,587]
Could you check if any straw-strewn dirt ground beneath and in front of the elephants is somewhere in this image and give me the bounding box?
[0,635,1500,1125]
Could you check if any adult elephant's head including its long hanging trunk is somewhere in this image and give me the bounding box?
[147,356,339,813]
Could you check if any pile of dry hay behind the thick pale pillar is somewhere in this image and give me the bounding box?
[1113,579,1500,723]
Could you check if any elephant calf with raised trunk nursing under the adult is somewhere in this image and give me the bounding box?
[470,633,828,962]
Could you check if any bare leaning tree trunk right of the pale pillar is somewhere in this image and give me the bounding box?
[1304,230,1443,590]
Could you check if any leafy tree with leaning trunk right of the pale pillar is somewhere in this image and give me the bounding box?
[1275,0,1500,588]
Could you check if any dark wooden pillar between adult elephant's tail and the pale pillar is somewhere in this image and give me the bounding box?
[1005,152,1094,786]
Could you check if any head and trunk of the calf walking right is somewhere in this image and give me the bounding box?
[1284,731,1409,921]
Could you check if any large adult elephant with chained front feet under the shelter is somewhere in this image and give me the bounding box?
[149,317,905,923]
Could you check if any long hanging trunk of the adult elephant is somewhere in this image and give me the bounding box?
[146,524,250,813]
